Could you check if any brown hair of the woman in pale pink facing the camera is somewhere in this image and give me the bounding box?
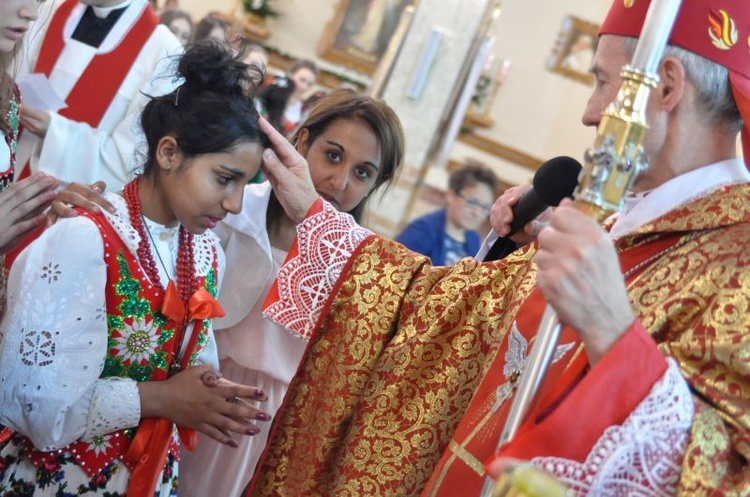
[291,89,404,221]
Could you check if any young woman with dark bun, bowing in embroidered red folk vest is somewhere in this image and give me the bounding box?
[0,40,268,496]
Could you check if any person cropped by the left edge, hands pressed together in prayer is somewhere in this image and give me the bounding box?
[0,0,59,316]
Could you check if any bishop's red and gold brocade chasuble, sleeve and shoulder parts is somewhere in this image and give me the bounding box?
[247,185,750,495]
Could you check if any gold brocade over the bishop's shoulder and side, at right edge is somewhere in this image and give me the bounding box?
[623,185,750,496]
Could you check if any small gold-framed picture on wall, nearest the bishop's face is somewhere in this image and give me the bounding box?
[547,16,599,85]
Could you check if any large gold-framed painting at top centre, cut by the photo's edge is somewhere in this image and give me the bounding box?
[318,0,414,75]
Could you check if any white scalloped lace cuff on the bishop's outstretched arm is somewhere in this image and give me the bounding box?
[264,202,373,340]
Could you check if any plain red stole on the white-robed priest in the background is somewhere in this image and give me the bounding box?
[20,0,159,179]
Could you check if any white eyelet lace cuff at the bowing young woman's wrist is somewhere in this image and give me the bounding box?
[81,378,141,441]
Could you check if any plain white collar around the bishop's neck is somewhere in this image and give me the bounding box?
[610,158,750,240]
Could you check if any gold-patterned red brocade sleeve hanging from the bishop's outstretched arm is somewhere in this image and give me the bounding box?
[252,239,534,496]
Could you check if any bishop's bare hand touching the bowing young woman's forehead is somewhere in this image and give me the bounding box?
[258,117,319,223]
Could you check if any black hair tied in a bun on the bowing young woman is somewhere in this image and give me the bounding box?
[141,40,266,175]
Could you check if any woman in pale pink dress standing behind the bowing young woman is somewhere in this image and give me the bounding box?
[53,90,404,497]
